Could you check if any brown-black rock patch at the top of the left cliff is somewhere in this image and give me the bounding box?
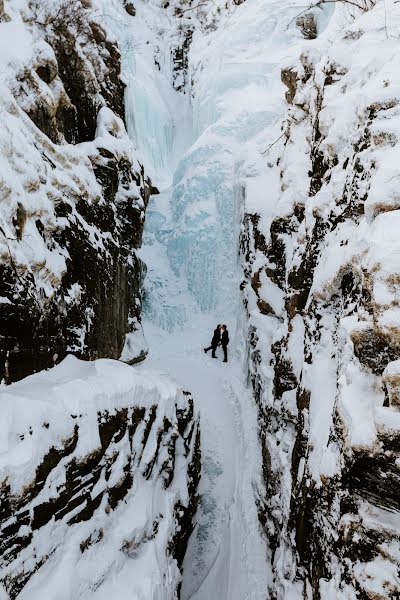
[13,0,124,144]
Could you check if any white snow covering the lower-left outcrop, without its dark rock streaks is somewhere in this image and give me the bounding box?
[0,355,198,600]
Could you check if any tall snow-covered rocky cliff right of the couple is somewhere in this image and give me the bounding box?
[242,3,400,599]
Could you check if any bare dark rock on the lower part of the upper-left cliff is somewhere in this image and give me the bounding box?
[0,150,148,382]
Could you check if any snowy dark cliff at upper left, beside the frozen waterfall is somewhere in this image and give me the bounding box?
[0,0,151,382]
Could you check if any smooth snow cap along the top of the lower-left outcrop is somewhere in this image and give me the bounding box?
[0,355,190,492]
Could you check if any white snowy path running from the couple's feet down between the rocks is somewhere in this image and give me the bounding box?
[141,315,267,600]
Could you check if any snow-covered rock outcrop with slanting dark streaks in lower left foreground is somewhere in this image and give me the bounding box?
[0,356,200,600]
